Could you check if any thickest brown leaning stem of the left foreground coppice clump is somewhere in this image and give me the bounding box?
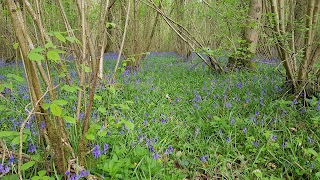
[5,0,68,173]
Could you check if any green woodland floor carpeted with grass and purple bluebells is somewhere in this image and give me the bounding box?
[0,53,320,179]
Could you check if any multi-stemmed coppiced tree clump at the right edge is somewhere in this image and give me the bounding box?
[270,0,320,96]
